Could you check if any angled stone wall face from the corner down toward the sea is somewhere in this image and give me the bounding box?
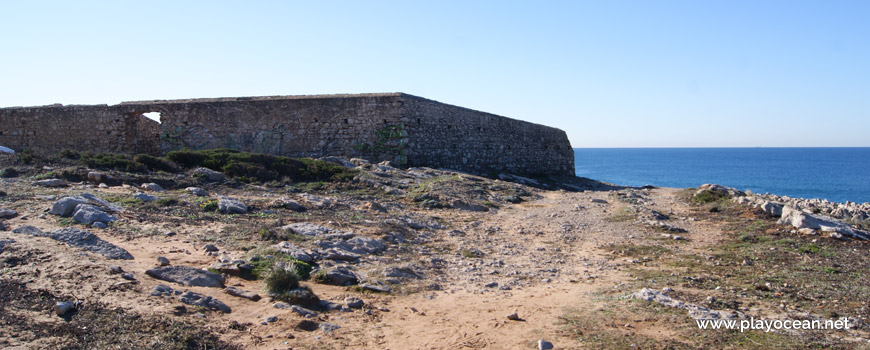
[403,96,574,175]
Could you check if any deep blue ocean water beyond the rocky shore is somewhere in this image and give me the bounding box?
[574,148,870,203]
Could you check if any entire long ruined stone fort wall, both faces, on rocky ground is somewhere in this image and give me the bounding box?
[0,93,574,175]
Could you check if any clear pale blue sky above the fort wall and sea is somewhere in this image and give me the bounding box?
[0,0,870,147]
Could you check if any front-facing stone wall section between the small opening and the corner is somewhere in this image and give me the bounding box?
[122,94,408,160]
